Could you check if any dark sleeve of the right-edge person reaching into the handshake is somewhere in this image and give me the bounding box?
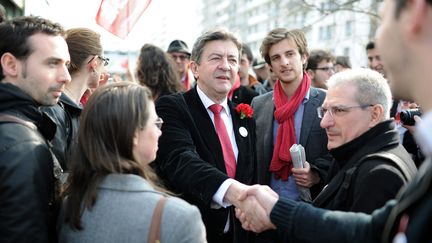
[270,157,432,243]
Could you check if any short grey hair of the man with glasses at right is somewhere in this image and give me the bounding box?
[327,68,392,119]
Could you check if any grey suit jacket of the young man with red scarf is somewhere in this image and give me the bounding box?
[252,87,333,198]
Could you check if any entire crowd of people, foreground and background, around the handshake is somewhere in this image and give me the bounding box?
[0,0,432,243]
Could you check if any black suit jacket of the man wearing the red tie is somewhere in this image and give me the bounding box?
[155,88,256,242]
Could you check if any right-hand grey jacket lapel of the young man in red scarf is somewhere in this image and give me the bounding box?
[300,88,320,146]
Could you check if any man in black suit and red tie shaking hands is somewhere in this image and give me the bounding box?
[156,30,256,242]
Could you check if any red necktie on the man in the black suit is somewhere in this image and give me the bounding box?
[209,104,236,178]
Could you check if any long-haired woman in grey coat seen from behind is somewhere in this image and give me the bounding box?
[59,82,205,243]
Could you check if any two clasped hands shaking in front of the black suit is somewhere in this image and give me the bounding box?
[233,183,279,233]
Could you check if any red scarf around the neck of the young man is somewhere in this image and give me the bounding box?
[270,72,311,181]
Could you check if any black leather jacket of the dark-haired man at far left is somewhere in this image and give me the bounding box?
[0,83,57,243]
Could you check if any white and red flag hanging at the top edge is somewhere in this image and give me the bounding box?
[96,0,151,39]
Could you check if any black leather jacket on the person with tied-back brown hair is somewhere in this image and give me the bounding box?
[43,93,82,170]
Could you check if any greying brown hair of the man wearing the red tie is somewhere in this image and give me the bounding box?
[191,28,242,64]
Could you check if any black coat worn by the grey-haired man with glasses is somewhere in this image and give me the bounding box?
[313,120,417,213]
